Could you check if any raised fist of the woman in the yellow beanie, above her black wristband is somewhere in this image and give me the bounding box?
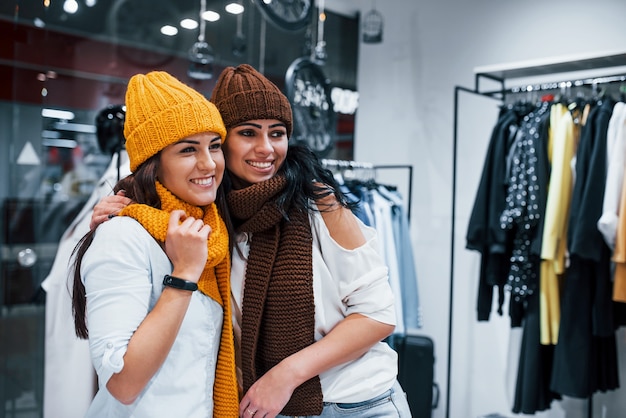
[165,210,211,283]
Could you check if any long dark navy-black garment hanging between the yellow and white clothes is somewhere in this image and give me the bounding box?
[550,98,619,398]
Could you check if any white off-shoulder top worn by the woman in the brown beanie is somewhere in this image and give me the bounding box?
[231,213,397,403]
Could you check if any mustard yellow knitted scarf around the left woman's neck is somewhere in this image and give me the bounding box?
[120,182,239,418]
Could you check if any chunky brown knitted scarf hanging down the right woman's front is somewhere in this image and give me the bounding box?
[227,176,323,415]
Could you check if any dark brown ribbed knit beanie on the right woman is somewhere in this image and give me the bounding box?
[211,64,293,136]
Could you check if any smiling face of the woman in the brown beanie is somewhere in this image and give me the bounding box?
[224,119,289,188]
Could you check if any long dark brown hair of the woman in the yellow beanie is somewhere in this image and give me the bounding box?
[70,153,234,339]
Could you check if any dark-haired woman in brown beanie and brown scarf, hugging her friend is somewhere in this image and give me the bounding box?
[92,64,410,418]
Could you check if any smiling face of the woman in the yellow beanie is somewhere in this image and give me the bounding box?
[157,132,224,206]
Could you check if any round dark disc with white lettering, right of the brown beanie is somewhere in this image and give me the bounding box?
[285,58,336,157]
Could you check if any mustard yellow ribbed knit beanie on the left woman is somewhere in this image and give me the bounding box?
[124,71,226,172]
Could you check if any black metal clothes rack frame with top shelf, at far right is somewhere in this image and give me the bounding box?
[446,51,626,418]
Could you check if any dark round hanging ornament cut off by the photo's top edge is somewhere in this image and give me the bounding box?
[254,0,313,30]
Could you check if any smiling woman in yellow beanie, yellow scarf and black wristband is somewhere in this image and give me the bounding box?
[73,72,239,418]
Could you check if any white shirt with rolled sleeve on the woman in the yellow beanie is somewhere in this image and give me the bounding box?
[81,216,223,418]
